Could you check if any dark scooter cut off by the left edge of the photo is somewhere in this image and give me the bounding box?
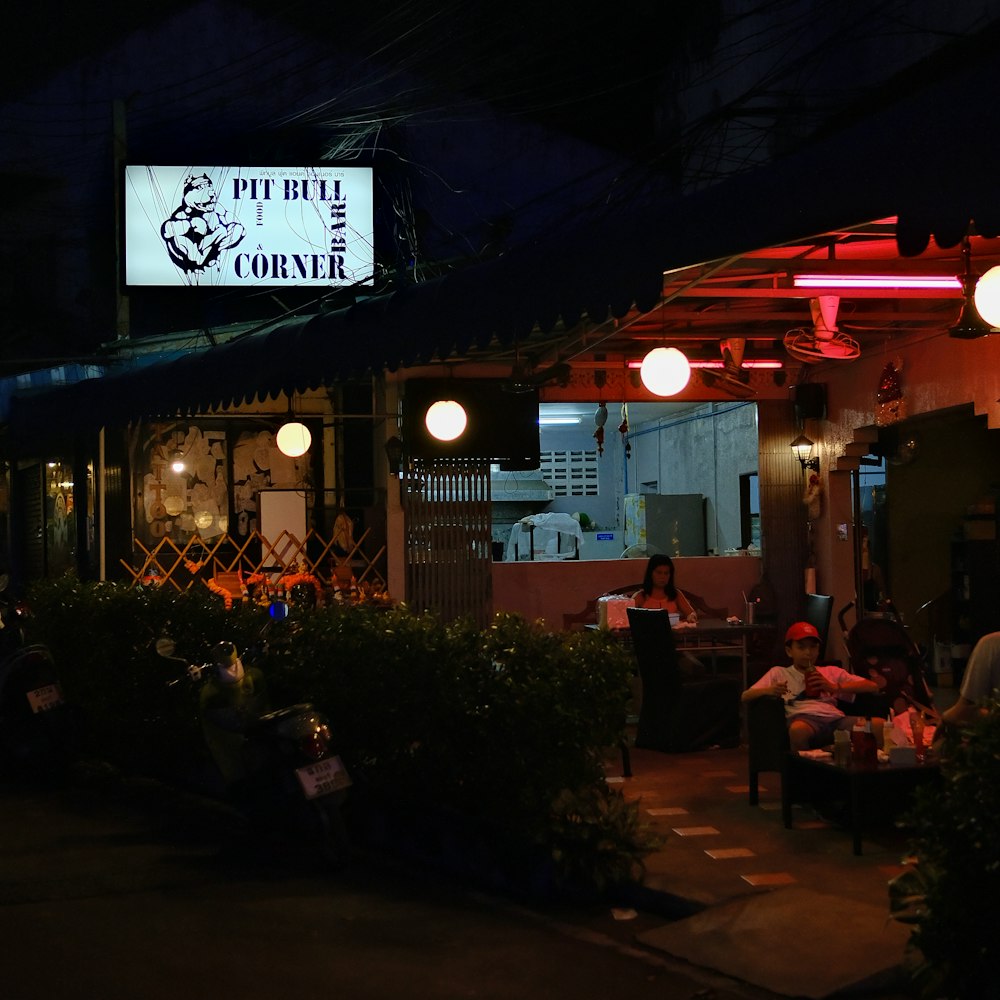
[0,574,76,777]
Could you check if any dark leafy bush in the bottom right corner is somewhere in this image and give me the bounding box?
[890,700,1000,1000]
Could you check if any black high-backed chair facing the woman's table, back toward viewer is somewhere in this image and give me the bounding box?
[628,608,740,753]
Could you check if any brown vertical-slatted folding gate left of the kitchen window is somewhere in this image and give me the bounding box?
[403,460,493,627]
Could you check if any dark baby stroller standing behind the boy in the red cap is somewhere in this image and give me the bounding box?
[837,601,940,724]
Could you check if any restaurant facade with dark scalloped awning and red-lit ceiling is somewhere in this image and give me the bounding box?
[5,5,1000,672]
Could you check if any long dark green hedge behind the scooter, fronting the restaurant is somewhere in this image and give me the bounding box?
[23,580,654,887]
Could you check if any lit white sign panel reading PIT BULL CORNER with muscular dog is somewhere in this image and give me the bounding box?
[125,166,375,287]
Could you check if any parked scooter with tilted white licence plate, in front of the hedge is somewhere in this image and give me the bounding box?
[156,639,351,866]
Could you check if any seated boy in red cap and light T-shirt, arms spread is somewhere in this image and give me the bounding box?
[742,622,882,750]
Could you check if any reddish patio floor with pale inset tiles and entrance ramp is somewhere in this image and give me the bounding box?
[608,749,909,997]
